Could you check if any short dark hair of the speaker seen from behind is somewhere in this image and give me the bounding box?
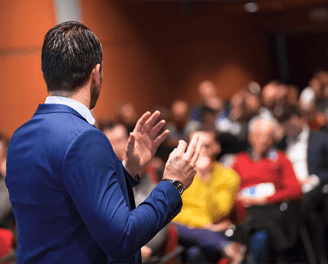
[41,21,103,92]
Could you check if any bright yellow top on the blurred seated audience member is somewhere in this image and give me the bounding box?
[173,162,240,228]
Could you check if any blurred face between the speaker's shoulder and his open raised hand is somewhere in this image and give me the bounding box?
[104,125,129,160]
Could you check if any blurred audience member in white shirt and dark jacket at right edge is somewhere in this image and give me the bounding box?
[285,108,328,263]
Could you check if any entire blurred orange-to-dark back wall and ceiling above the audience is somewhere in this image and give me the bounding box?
[0,0,328,137]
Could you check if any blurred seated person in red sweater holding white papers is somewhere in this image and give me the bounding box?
[232,117,302,263]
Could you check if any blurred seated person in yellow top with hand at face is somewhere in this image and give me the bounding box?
[173,131,245,263]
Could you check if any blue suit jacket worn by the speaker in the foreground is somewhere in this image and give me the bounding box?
[6,104,182,263]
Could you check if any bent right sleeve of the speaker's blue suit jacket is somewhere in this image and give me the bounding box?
[63,129,182,261]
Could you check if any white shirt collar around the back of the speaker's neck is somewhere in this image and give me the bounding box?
[45,96,95,125]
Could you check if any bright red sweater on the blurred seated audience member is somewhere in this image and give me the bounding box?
[233,151,302,203]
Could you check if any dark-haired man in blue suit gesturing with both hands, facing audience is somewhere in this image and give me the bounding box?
[6,22,201,263]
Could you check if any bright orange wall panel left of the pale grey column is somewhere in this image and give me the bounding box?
[0,0,55,136]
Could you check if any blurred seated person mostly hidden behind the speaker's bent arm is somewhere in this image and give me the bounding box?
[99,121,168,262]
